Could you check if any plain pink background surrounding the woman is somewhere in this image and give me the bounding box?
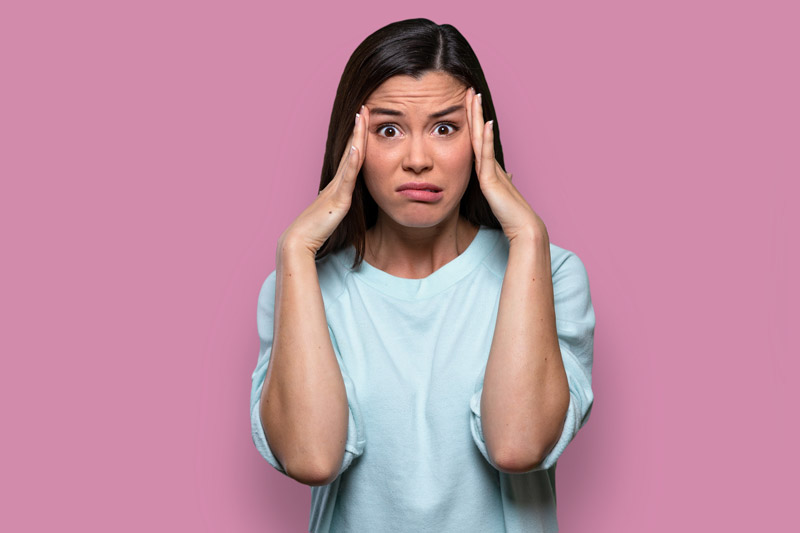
[0,0,800,533]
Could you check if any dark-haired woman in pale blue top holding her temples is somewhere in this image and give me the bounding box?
[250,19,595,532]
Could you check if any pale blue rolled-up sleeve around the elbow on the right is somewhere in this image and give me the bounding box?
[470,252,595,472]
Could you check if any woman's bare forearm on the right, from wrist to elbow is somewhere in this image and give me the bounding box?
[481,230,569,471]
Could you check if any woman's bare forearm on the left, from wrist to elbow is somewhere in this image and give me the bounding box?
[261,238,348,484]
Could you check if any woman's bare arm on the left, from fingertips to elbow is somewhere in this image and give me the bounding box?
[251,106,369,485]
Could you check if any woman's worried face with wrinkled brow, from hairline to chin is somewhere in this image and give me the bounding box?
[362,71,473,227]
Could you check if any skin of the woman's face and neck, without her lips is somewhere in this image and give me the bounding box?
[362,72,478,278]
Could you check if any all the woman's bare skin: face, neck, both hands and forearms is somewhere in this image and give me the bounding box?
[261,72,569,486]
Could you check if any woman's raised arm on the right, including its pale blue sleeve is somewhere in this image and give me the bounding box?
[466,89,594,473]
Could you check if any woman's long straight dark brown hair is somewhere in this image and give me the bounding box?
[316,18,505,268]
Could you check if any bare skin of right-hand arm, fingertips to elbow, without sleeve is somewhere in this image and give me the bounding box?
[466,82,570,473]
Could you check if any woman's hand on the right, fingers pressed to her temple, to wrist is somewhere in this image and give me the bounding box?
[466,88,549,242]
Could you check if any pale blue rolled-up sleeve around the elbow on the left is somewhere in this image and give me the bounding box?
[250,271,366,475]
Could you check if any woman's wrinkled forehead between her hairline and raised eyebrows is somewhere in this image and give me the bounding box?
[366,72,467,111]
